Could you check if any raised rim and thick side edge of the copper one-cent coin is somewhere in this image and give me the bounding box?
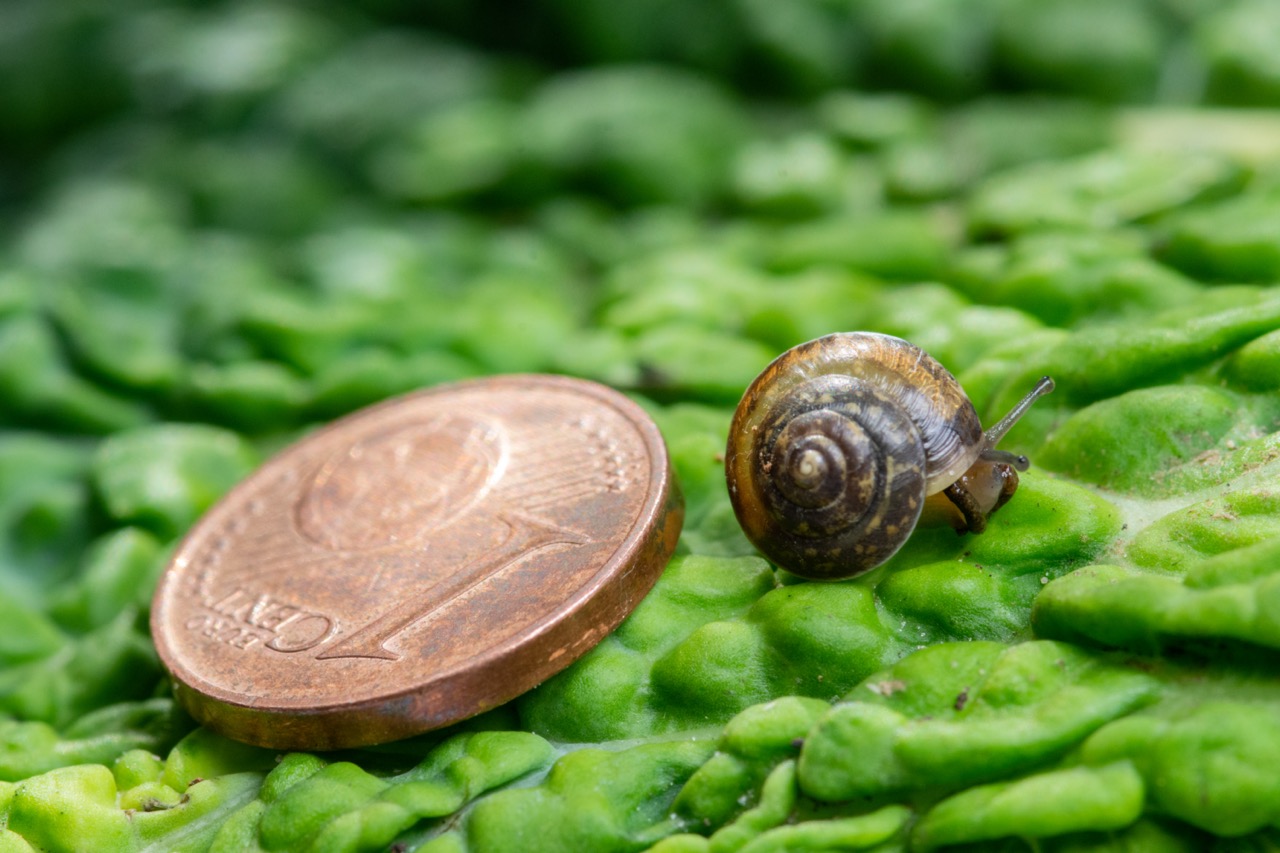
[151,374,684,749]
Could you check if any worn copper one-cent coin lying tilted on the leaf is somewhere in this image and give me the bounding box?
[151,375,684,749]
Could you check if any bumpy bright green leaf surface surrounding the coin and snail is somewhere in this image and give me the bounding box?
[0,0,1280,853]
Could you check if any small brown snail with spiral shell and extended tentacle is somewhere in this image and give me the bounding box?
[724,332,1053,580]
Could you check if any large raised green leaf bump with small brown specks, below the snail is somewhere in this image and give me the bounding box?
[800,640,1156,802]
